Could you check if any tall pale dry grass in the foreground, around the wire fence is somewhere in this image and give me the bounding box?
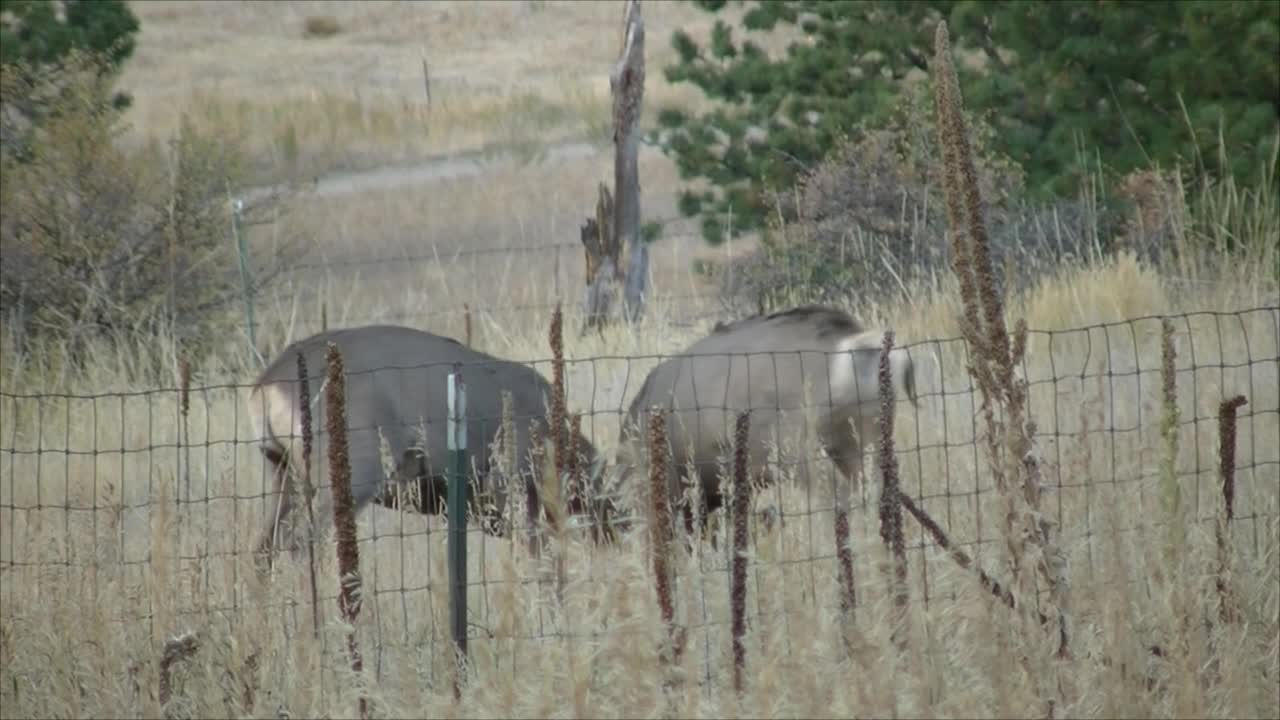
[0,251,1280,716]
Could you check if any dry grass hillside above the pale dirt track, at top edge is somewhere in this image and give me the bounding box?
[122,0,747,183]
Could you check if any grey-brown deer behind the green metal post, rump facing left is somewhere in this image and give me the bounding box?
[248,325,611,570]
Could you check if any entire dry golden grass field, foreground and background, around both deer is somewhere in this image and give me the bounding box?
[0,1,1280,717]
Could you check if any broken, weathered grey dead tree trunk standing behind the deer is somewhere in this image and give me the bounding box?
[582,0,649,328]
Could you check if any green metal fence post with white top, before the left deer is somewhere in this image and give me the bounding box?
[448,365,467,697]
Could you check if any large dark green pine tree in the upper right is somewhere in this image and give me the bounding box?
[654,0,1280,243]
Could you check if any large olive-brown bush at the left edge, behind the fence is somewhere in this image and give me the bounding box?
[0,53,294,360]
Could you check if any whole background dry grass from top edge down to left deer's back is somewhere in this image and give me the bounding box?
[102,1,768,351]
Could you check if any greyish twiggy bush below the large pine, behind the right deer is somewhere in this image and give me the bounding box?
[718,83,1116,311]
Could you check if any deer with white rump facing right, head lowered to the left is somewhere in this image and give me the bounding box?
[620,305,916,533]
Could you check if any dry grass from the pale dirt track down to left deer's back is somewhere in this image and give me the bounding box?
[240,141,727,351]
